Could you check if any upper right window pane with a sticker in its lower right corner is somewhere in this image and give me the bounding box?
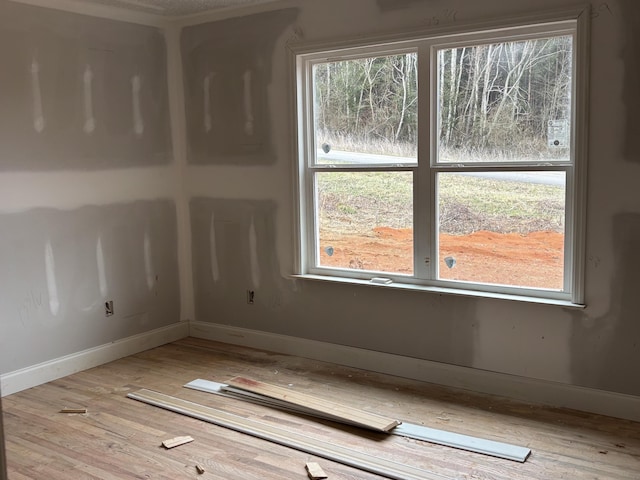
[437,36,573,163]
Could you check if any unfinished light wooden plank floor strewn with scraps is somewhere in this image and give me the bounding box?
[3,338,640,480]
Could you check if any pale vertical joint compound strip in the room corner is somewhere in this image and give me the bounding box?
[165,22,195,320]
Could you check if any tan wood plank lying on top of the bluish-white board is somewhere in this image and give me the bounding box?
[223,377,400,432]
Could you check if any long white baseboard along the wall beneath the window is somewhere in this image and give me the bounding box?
[189,322,640,422]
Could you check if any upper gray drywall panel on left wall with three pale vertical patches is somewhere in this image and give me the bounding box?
[0,2,172,171]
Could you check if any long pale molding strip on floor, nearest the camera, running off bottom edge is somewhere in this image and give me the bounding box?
[127,389,446,480]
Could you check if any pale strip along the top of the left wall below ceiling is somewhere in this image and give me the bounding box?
[8,0,170,28]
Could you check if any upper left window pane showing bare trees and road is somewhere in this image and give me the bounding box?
[313,53,418,165]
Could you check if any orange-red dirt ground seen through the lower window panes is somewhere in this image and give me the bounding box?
[320,227,564,289]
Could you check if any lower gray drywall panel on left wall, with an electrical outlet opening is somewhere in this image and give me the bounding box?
[0,200,180,373]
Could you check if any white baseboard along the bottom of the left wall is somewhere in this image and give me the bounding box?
[0,322,189,396]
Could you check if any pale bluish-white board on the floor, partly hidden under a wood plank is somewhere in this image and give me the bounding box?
[185,378,531,463]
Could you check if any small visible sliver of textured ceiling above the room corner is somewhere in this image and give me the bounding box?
[71,0,274,17]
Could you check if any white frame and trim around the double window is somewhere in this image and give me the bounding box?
[289,5,590,308]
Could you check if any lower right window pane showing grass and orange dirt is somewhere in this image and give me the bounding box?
[437,172,565,290]
